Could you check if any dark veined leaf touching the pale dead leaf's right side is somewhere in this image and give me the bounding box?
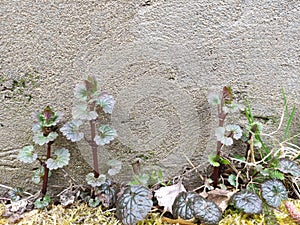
[172,192,200,220]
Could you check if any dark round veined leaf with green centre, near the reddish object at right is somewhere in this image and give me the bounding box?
[261,179,287,208]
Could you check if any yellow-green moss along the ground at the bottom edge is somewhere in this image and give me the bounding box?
[0,200,300,225]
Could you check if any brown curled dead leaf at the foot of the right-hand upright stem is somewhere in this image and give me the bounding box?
[207,189,235,212]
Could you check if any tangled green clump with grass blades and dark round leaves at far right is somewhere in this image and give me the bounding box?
[228,96,300,218]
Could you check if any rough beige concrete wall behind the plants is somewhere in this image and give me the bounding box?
[0,0,300,193]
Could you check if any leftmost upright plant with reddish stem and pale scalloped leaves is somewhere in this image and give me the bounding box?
[17,106,70,208]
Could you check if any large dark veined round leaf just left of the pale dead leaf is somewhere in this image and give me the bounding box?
[116,186,153,225]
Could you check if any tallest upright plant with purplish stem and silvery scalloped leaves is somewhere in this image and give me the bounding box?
[60,76,121,187]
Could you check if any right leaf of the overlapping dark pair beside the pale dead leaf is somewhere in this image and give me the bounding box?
[192,196,222,225]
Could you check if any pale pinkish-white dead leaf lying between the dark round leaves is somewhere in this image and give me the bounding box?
[154,182,186,213]
